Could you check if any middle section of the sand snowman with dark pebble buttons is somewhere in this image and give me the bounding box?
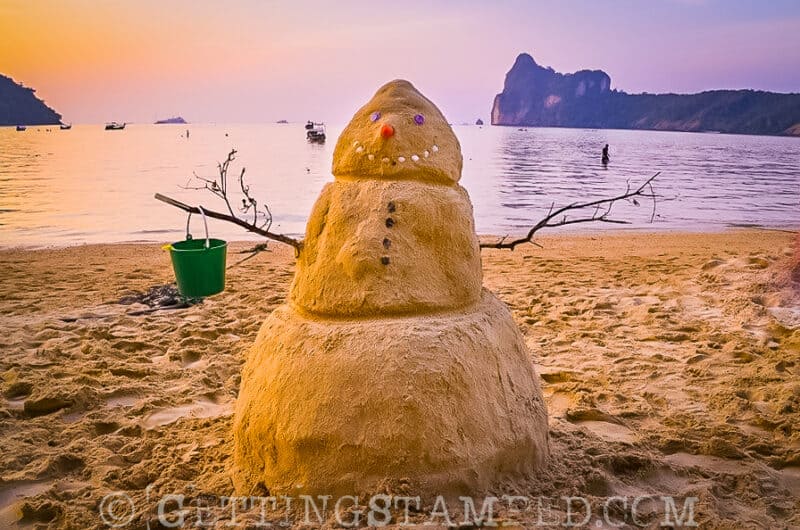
[290,177,482,317]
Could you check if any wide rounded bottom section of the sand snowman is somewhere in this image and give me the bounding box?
[233,289,548,498]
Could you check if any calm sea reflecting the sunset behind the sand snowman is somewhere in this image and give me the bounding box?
[0,124,800,247]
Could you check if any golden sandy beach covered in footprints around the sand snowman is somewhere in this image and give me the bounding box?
[0,230,800,529]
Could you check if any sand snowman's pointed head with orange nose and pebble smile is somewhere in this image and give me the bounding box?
[333,79,462,184]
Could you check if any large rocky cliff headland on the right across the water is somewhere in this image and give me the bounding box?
[492,53,800,136]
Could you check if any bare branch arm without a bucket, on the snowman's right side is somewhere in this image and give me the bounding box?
[480,171,661,250]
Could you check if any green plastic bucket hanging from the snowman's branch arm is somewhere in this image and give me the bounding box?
[165,208,228,298]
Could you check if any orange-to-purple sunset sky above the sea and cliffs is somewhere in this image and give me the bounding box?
[0,0,800,123]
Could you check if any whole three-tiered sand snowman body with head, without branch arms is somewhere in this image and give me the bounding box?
[233,81,548,496]
